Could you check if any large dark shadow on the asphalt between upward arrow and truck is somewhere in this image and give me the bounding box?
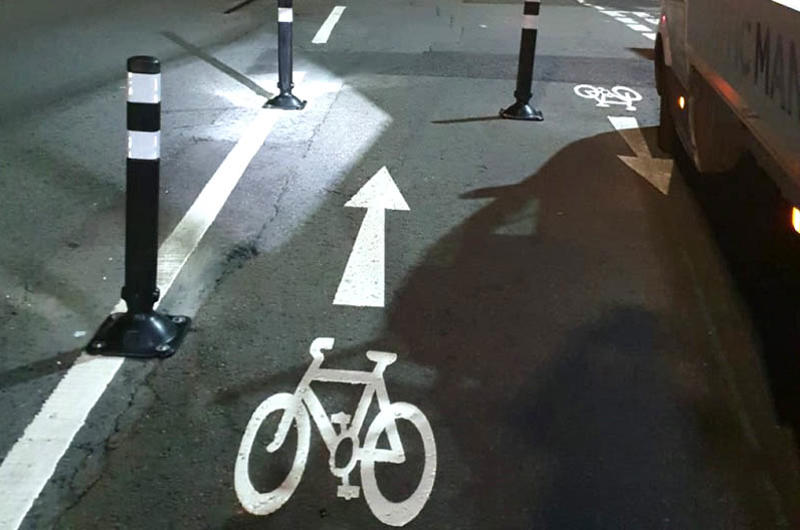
[215,130,797,528]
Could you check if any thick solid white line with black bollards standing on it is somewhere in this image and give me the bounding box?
[0,105,280,530]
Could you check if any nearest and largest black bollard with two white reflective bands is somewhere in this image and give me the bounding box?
[87,56,189,357]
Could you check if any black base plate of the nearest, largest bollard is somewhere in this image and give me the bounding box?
[86,311,191,359]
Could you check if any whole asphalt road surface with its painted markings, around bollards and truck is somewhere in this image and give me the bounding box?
[0,0,800,530]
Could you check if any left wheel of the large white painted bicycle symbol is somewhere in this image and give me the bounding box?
[233,393,311,515]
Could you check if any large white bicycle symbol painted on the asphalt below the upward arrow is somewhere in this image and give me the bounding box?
[234,337,436,526]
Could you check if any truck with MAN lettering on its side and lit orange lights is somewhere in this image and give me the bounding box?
[655,0,800,225]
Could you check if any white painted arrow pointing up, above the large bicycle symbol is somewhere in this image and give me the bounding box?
[333,166,410,307]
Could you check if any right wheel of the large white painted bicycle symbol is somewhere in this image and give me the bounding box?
[361,402,436,526]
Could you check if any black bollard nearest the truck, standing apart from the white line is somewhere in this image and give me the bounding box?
[500,0,544,121]
